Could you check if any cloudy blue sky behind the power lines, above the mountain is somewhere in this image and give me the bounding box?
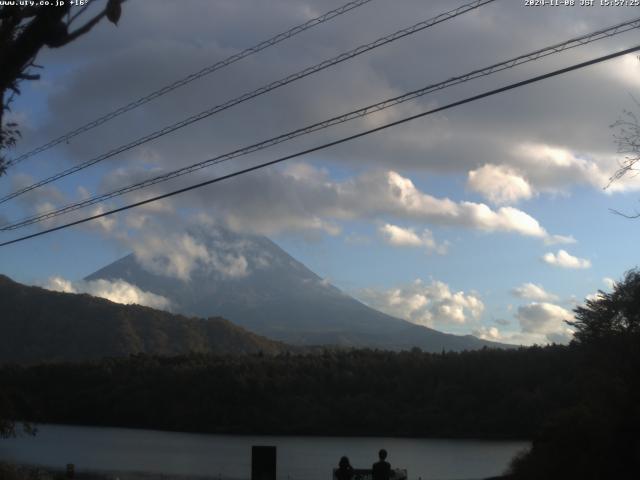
[0,0,640,343]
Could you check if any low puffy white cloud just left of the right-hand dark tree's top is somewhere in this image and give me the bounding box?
[516,302,574,343]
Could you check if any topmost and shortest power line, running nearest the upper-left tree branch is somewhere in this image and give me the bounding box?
[7,0,371,167]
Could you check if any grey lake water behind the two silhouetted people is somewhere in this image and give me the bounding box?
[0,425,528,480]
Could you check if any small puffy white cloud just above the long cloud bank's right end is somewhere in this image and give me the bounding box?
[467,164,534,205]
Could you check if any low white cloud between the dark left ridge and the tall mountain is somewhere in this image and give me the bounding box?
[45,277,171,310]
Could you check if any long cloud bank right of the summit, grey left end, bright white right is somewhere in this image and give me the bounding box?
[142,166,564,240]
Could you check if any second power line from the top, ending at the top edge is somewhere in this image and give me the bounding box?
[0,0,495,204]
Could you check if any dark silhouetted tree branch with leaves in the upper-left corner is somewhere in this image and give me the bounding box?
[0,0,124,175]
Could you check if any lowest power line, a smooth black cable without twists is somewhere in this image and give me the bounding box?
[0,45,640,247]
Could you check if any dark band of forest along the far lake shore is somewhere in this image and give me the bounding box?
[0,346,580,438]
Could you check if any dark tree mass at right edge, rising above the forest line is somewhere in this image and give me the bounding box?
[504,270,640,480]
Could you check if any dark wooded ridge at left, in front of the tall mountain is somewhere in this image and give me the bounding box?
[0,275,287,362]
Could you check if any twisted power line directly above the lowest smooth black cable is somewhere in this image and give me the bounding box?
[0,18,640,231]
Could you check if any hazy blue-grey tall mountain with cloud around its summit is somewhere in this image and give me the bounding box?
[85,227,516,352]
